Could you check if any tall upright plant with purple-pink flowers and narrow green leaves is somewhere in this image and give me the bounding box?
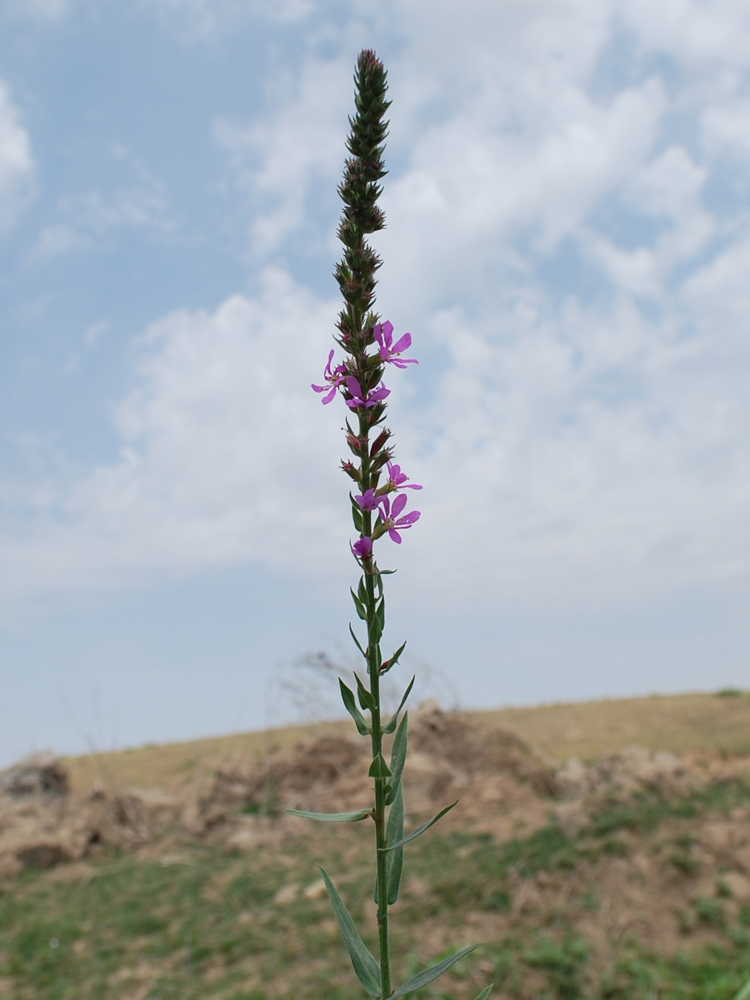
[290,50,492,1000]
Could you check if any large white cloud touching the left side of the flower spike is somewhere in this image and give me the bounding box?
[1,270,348,586]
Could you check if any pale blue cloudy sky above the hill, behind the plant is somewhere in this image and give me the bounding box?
[0,0,750,763]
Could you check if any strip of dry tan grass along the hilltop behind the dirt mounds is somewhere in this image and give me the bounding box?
[67,694,750,790]
